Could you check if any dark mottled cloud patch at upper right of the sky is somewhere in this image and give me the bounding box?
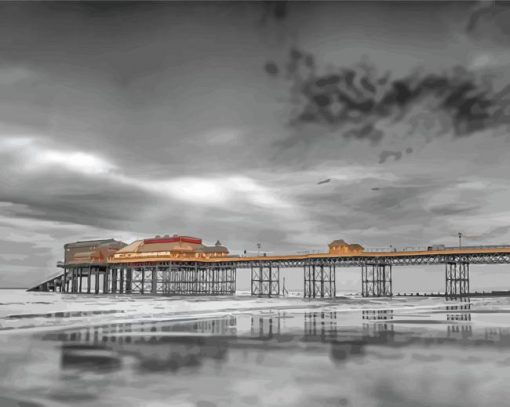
[266,48,510,144]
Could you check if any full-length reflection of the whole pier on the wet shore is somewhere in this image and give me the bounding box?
[36,303,510,378]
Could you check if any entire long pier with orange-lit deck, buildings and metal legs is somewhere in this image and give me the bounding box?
[29,235,510,298]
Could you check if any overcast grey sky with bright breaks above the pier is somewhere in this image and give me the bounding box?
[0,1,510,287]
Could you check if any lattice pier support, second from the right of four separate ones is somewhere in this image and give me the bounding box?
[361,263,393,297]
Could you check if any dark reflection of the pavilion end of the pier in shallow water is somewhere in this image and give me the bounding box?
[55,317,236,372]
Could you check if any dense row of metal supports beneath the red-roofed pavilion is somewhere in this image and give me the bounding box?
[105,262,237,295]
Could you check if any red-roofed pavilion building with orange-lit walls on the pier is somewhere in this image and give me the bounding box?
[112,235,229,262]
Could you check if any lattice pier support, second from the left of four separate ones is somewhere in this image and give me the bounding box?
[304,263,336,298]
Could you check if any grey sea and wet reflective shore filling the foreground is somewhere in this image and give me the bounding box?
[0,290,510,407]
